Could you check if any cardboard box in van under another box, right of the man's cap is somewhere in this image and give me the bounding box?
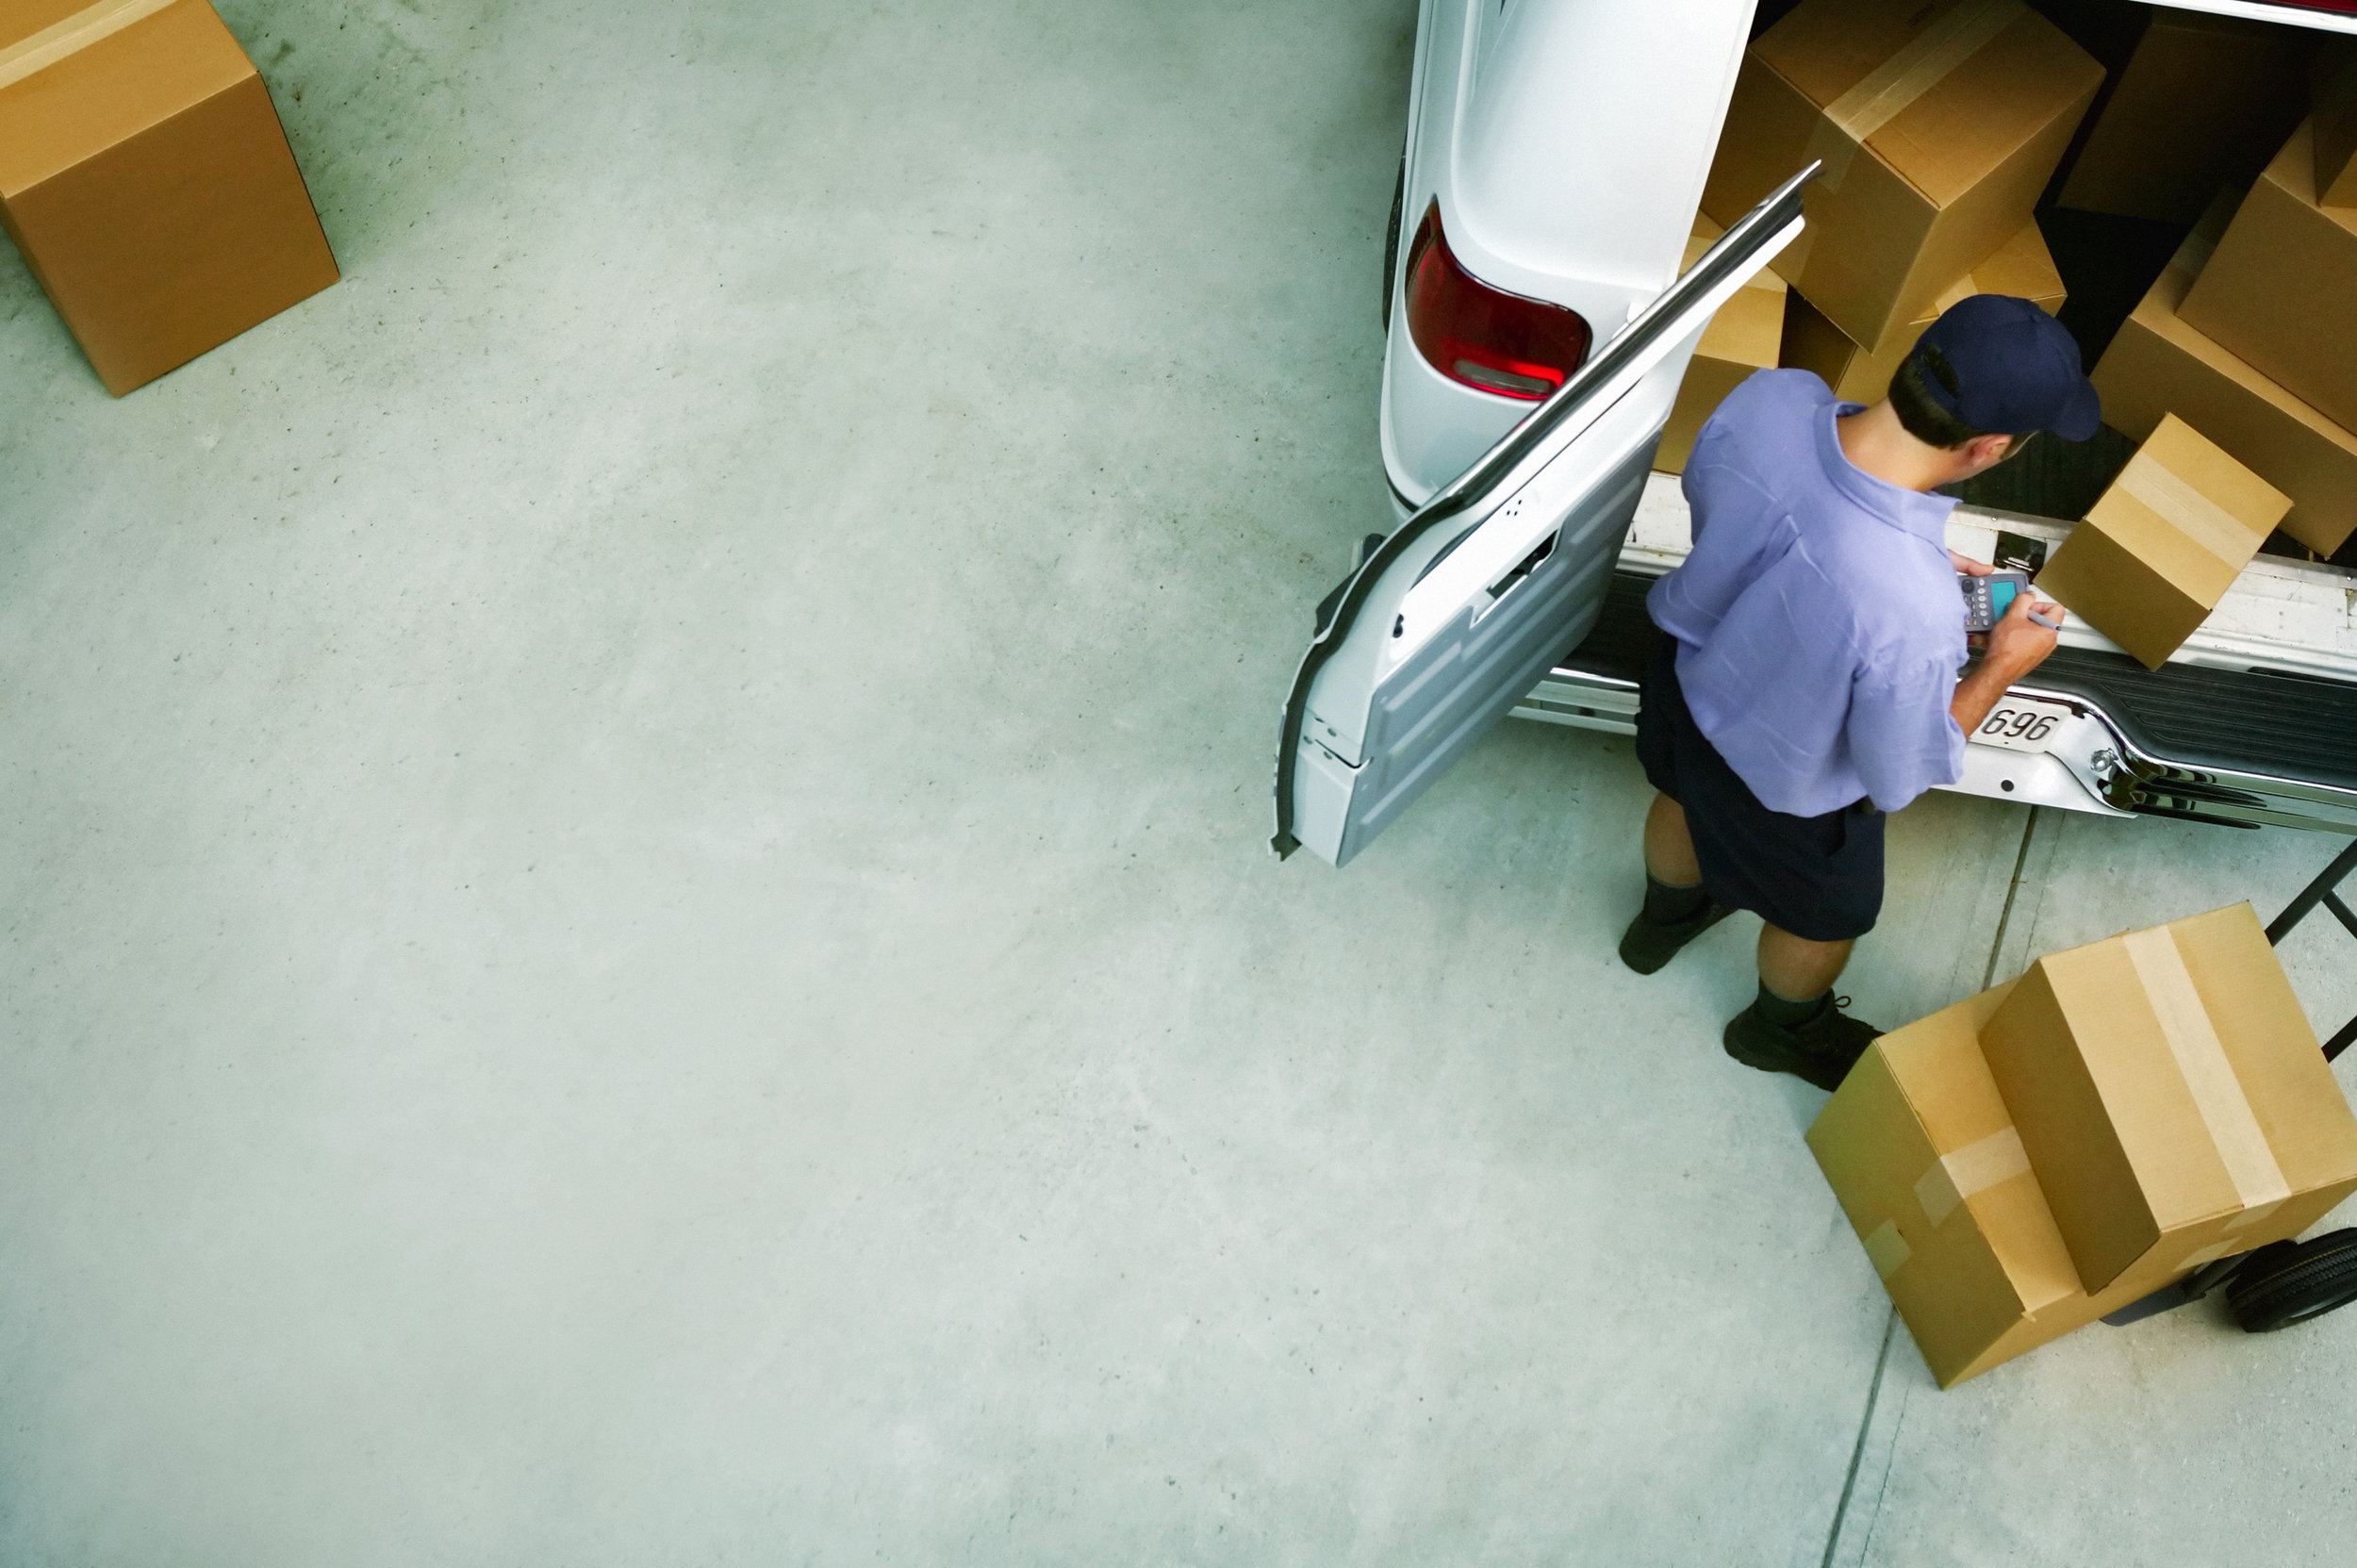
[2096,212,2357,556]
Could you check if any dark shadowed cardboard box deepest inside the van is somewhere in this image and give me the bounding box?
[2058,9,2308,224]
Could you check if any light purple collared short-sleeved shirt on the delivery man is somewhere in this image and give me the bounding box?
[1645,371,1964,816]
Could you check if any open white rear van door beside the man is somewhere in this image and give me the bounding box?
[1271,165,1818,866]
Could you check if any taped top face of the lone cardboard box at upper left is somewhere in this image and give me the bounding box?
[0,0,255,198]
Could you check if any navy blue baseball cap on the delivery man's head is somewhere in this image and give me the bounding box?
[1914,295,2102,441]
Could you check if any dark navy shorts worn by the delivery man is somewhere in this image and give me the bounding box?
[1636,632,1884,941]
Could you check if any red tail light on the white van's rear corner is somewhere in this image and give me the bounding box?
[1408,203,1589,401]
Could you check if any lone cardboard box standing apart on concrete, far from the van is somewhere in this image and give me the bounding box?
[0,0,338,396]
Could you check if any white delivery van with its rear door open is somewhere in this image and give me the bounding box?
[1273,0,2357,866]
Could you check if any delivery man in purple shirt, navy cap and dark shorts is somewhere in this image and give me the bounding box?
[1620,295,2101,1089]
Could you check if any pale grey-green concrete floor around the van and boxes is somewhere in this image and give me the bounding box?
[0,0,2357,1568]
